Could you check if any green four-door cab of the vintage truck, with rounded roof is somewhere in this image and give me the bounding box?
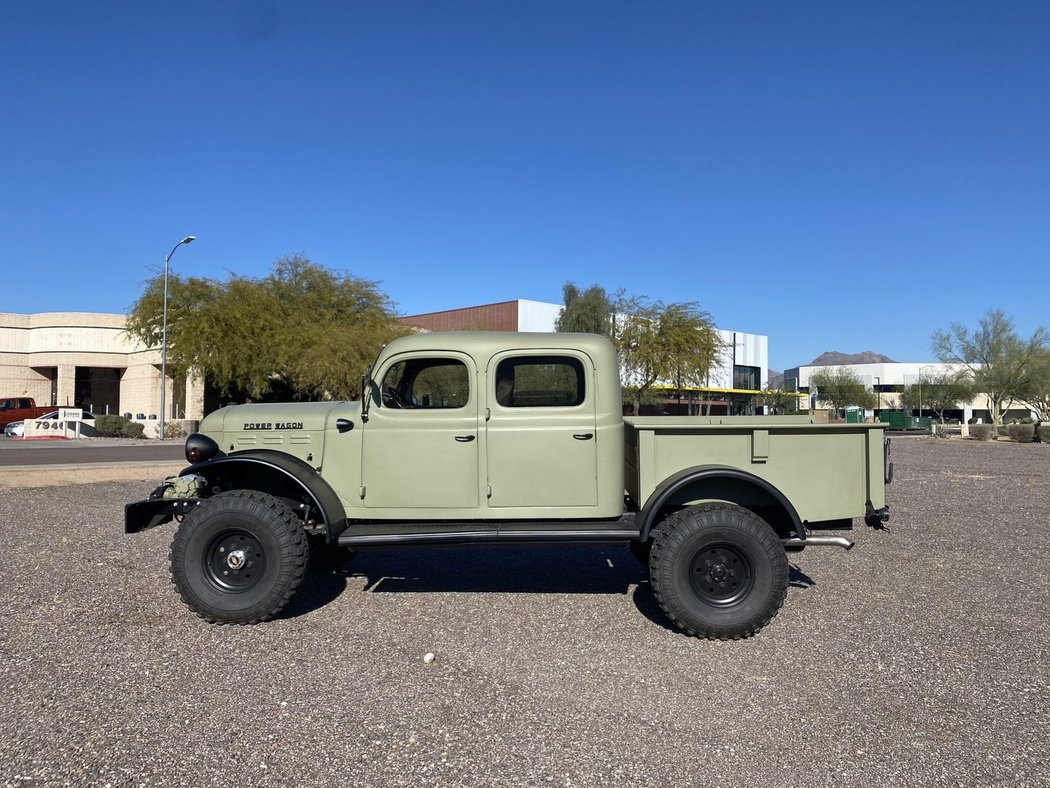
[348,333,624,519]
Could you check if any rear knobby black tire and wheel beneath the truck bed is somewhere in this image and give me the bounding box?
[649,503,788,640]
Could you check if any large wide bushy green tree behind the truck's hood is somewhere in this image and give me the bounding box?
[127,256,407,400]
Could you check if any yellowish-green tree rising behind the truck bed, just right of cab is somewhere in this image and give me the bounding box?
[610,291,723,413]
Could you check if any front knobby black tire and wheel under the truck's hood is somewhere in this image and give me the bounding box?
[170,490,310,624]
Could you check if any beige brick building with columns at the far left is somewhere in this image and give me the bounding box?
[0,312,204,434]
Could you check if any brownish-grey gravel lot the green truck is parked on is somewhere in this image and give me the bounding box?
[0,437,1050,788]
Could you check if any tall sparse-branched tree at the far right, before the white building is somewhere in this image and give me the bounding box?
[931,309,1050,424]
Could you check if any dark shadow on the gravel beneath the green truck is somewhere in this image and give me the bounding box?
[279,547,817,631]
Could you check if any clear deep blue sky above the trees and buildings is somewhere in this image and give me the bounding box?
[0,1,1050,369]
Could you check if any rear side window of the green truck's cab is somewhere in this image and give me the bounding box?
[496,356,587,408]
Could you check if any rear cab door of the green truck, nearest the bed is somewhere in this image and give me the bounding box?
[485,350,597,517]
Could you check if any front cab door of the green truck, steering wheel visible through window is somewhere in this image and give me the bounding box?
[361,352,480,517]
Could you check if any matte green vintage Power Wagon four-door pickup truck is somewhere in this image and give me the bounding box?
[125,332,891,639]
